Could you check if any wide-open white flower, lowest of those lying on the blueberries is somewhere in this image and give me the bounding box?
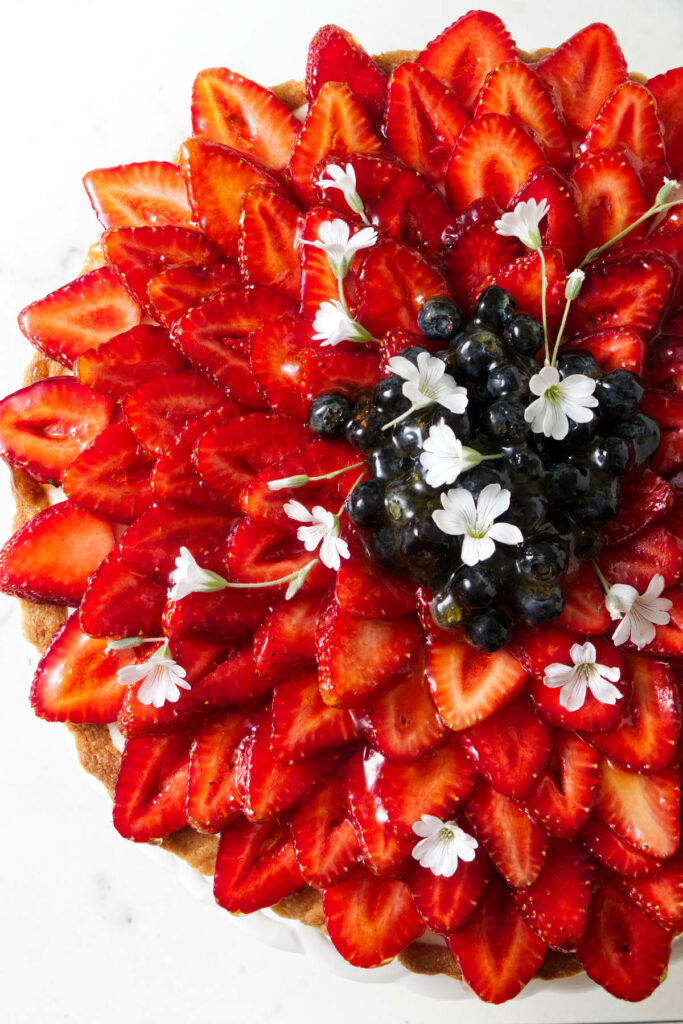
[432,483,524,565]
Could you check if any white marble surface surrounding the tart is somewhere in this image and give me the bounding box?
[0,0,683,1024]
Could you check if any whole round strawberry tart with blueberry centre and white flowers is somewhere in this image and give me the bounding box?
[0,11,683,1002]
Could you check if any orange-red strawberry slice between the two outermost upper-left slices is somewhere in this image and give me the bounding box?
[180,138,279,257]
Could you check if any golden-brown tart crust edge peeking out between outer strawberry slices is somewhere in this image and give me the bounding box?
[11,47,602,981]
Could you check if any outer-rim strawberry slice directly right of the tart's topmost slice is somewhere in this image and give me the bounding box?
[536,23,627,137]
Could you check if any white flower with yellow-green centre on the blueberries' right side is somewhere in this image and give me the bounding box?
[524,367,598,441]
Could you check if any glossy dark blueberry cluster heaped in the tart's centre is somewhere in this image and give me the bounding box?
[308,286,659,651]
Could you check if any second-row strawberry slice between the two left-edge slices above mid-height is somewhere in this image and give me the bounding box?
[74,324,185,398]
